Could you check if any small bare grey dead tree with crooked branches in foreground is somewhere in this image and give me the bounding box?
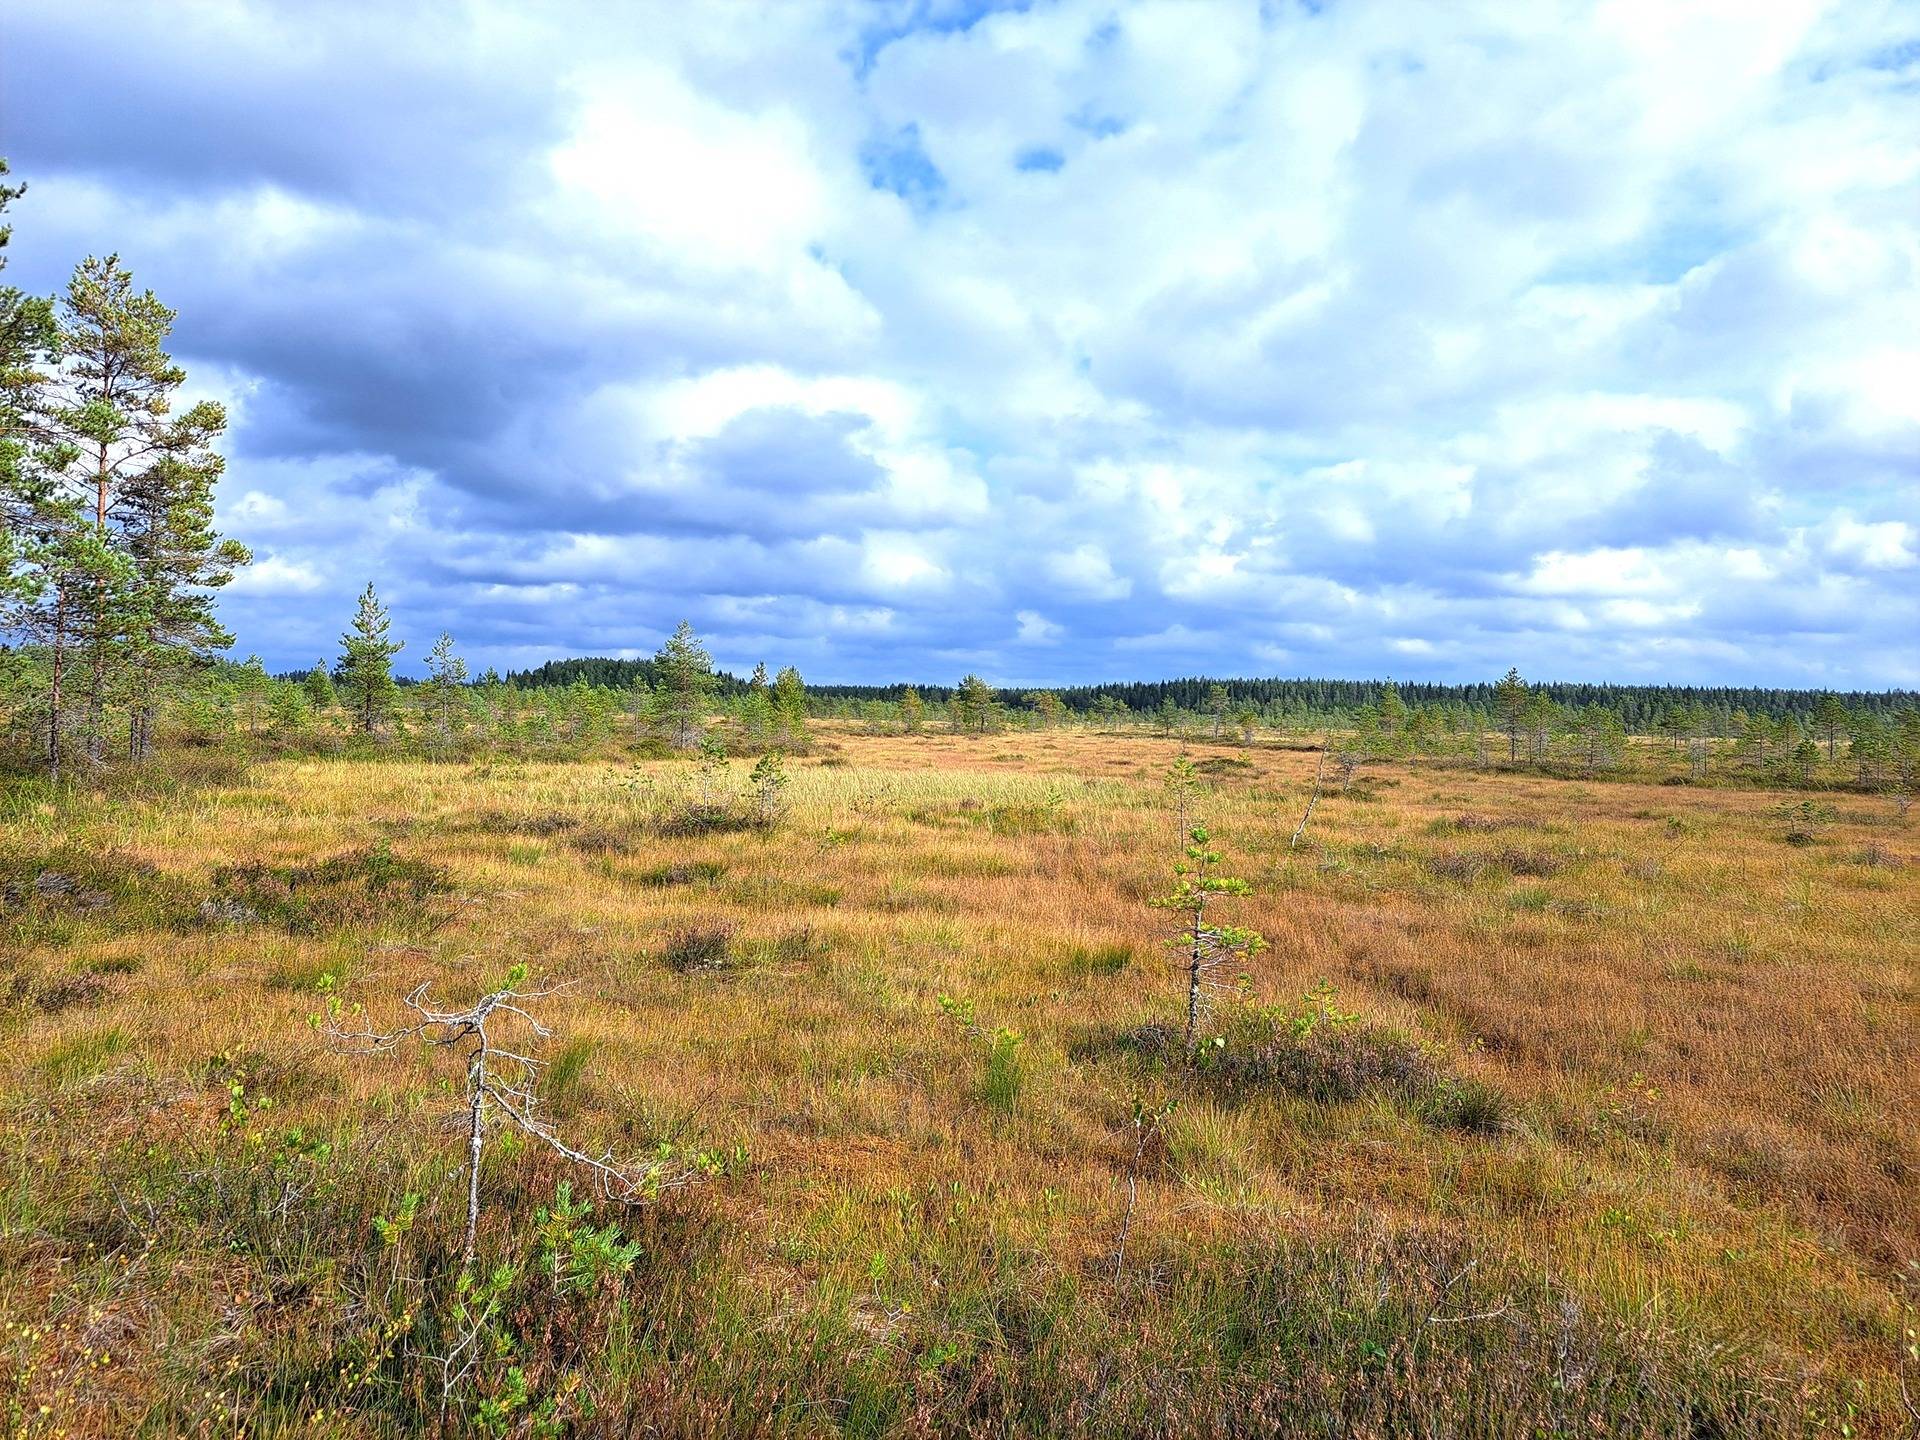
[317,964,701,1265]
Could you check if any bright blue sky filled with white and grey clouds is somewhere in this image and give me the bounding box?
[0,0,1920,687]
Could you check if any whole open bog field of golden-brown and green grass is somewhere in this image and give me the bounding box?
[0,732,1920,1436]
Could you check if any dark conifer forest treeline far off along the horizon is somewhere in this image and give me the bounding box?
[507,659,1920,733]
